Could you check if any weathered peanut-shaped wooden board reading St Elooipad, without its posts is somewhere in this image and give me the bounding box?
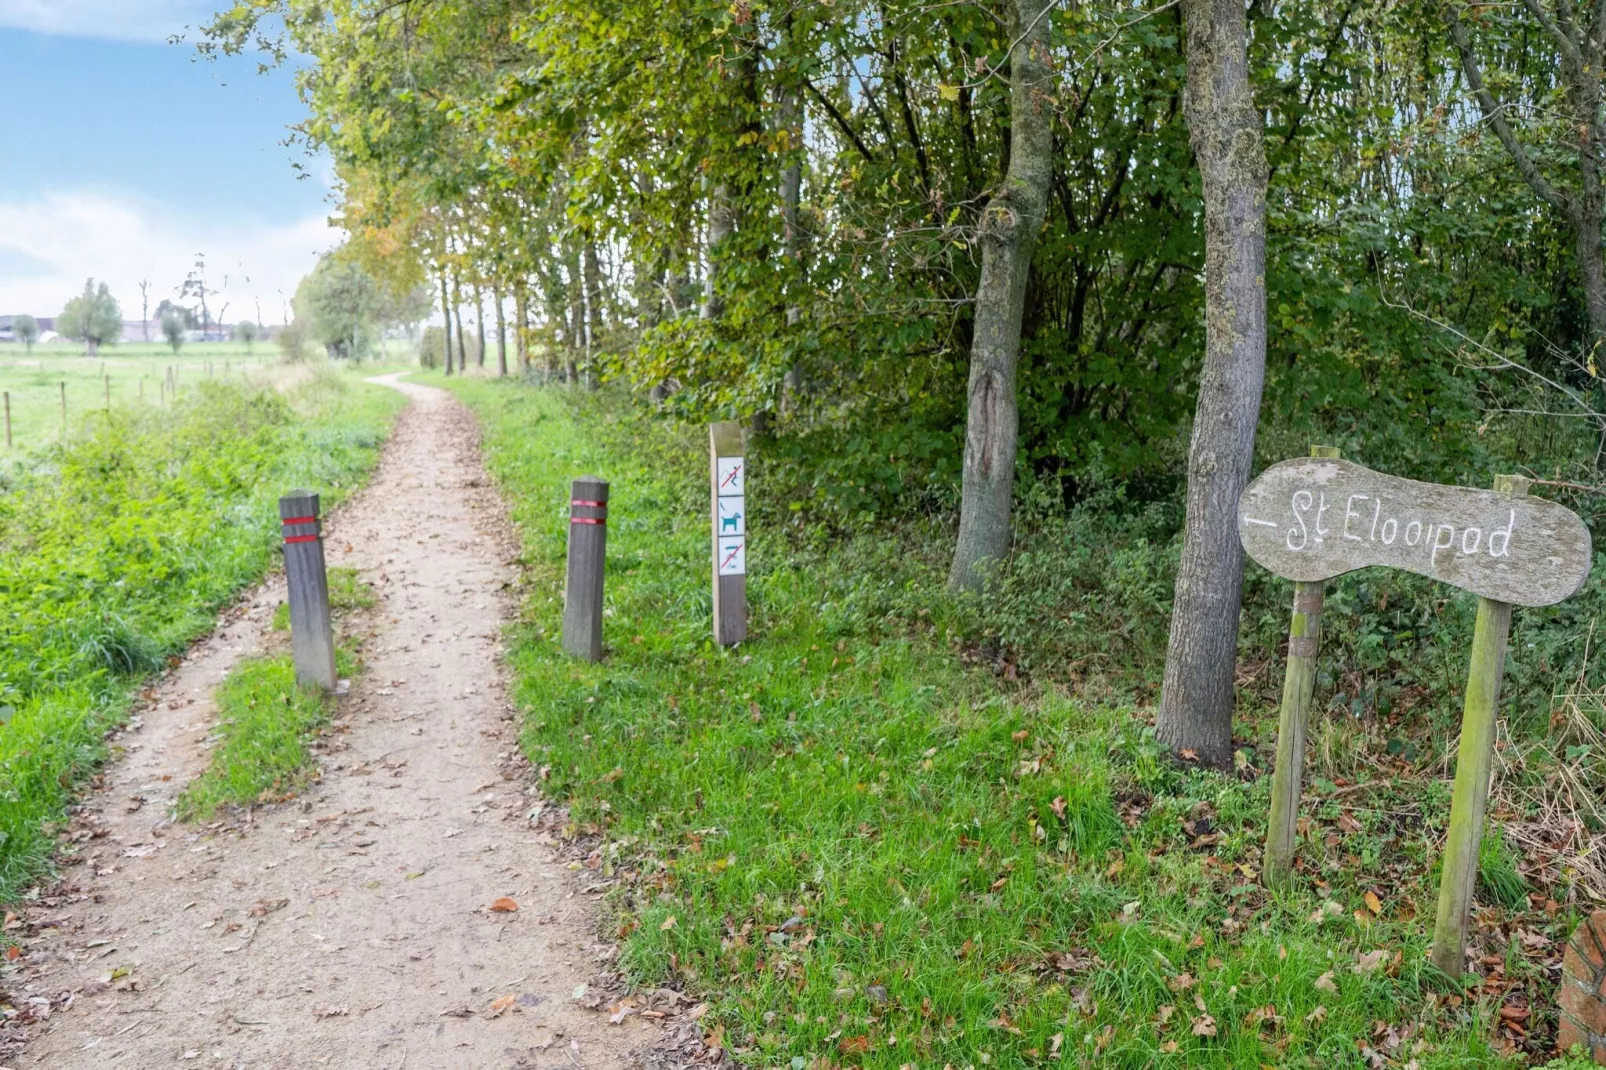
[1238,458,1592,606]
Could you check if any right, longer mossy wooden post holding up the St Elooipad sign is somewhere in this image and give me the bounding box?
[1433,476,1529,978]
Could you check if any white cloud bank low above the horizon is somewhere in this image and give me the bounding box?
[0,191,344,323]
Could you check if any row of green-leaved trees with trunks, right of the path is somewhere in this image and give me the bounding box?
[202,0,1606,762]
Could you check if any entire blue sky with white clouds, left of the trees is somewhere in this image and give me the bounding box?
[0,0,340,323]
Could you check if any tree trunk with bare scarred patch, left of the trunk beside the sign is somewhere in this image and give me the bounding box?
[948,0,1054,591]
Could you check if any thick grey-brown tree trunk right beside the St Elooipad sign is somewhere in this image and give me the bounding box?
[1155,0,1267,766]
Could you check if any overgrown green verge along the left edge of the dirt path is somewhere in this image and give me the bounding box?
[0,374,403,900]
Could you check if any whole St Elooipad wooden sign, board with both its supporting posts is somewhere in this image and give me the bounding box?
[1238,456,1592,977]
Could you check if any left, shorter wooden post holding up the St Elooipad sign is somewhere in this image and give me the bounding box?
[1261,447,1339,888]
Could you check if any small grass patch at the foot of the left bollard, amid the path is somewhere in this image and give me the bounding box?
[178,647,357,821]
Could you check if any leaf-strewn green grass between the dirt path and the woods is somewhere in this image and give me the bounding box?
[433,374,1575,1070]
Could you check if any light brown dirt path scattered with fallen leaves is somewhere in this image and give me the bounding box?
[10,376,654,1070]
